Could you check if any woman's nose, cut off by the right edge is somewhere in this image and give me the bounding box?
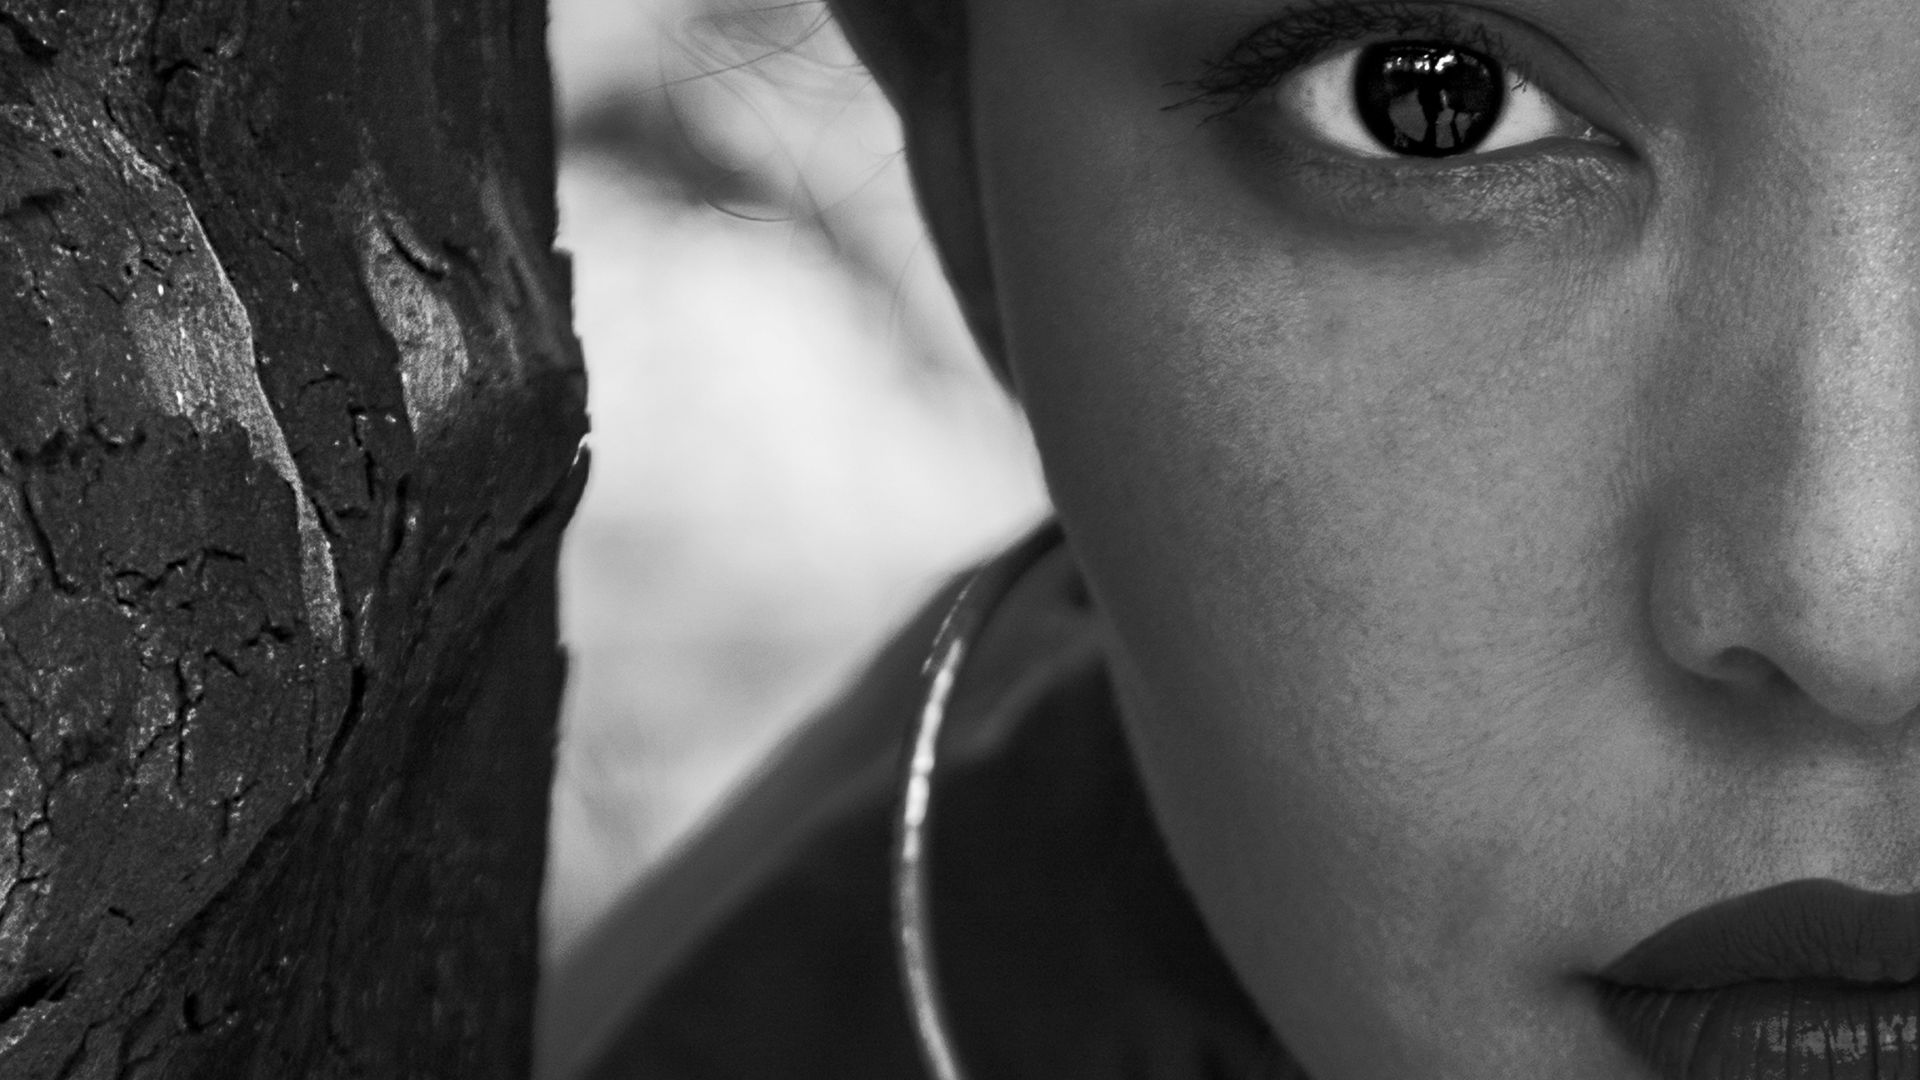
[1651,171,1920,728]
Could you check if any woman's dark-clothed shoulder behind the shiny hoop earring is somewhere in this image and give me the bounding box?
[555,534,1284,1080]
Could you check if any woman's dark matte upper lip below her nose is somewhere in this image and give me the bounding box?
[1599,880,1920,990]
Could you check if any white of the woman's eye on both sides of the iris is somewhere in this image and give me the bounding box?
[1279,46,1588,158]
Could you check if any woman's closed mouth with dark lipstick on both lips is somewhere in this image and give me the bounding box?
[1599,880,1920,1080]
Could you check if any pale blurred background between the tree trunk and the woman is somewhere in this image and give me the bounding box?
[543,0,1044,1030]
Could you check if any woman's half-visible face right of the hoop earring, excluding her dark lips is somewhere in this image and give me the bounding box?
[970,0,1920,1080]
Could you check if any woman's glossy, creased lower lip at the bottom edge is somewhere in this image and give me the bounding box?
[1599,982,1920,1080]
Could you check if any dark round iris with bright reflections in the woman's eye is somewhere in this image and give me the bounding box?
[1354,42,1507,158]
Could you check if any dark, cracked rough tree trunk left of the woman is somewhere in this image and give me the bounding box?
[0,0,586,1080]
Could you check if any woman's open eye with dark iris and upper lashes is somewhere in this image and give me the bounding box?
[1196,4,1619,163]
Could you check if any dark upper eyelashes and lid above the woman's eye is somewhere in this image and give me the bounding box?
[1167,0,1532,121]
